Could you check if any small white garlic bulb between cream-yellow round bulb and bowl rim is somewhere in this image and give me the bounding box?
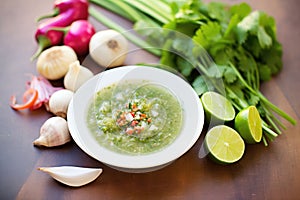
[64,61,94,92]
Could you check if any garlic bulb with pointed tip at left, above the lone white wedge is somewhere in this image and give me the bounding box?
[33,117,71,147]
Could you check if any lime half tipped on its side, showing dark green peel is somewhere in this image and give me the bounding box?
[234,106,262,144]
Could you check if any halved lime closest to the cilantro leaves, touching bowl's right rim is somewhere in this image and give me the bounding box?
[201,91,235,121]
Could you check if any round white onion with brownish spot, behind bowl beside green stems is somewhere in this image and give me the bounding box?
[89,29,129,67]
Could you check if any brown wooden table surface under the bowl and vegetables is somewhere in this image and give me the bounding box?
[0,0,300,200]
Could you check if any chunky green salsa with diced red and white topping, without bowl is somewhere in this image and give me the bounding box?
[87,80,183,154]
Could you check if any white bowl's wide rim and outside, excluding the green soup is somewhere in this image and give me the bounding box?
[68,66,204,173]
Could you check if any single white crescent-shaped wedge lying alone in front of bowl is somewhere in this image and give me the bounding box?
[38,166,102,187]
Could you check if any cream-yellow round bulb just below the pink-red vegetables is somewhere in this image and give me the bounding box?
[36,45,77,80]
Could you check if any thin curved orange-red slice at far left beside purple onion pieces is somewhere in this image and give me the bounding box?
[10,88,38,110]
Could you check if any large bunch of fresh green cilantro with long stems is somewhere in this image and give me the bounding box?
[90,0,296,145]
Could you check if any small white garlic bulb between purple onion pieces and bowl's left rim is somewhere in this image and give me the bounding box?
[49,89,74,118]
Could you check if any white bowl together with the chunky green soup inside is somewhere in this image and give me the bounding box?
[67,66,204,173]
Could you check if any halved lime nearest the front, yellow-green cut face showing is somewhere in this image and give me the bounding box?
[204,125,245,164]
